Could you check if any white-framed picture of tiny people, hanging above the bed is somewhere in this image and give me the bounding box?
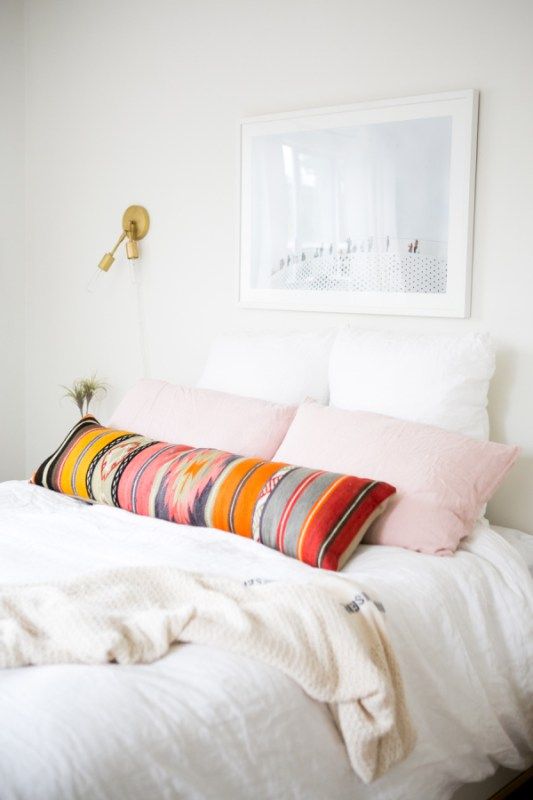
[240,90,478,317]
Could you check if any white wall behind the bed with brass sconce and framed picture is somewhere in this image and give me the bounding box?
[23,0,533,531]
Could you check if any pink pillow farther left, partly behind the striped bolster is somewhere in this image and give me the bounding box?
[109,380,296,460]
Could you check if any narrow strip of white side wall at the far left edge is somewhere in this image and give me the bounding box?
[0,0,24,480]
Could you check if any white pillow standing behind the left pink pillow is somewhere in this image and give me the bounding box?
[197,331,334,405]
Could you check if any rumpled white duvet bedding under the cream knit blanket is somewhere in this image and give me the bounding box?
[0,482,533,800]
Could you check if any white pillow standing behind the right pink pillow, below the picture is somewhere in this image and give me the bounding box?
[329,328,495,439]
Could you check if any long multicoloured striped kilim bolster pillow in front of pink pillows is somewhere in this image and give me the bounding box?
[32,415,396,570]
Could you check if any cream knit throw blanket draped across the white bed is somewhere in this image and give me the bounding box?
[0,567,414,783]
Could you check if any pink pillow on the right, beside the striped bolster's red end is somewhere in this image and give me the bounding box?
[274,400,518,555]
